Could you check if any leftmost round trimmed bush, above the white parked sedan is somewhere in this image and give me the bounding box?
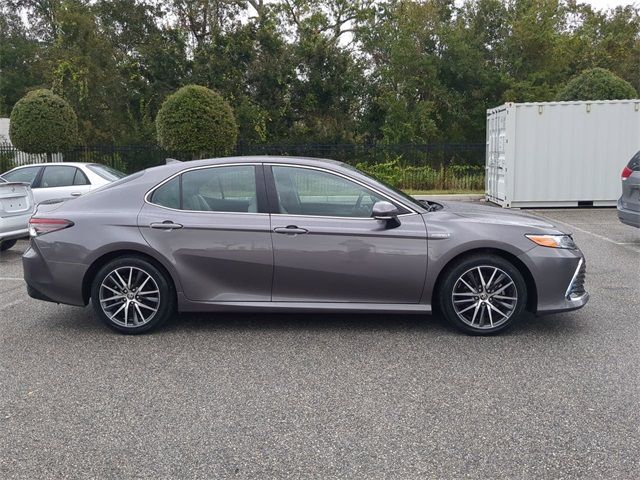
[9,89,78,153]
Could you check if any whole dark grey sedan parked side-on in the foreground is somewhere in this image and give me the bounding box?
[23,157,589,334]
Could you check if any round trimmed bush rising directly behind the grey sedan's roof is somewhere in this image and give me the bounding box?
[156,85,238,159]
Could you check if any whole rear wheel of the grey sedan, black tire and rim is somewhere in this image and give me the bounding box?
[91,255,176,335]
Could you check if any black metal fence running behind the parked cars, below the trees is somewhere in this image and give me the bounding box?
[0,143,485,190]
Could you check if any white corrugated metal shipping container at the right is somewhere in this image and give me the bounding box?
[486,99,640,208]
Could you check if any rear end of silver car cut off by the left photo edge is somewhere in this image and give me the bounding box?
[0,177,34,252]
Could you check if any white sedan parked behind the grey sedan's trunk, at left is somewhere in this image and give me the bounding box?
[2,162,126,205]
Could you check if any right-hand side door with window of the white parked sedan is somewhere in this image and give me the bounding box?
[33,165,91,203]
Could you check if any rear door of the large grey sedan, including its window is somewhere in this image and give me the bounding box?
[138,164,273,302]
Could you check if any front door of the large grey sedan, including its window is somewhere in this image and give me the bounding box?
[267,165,427,303]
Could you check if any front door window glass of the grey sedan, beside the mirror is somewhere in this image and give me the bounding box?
[272,166,388,217]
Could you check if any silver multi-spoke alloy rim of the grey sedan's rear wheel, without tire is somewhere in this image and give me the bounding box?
[100,267,160,328]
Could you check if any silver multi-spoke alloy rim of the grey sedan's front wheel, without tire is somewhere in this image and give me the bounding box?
[451,265,518,329]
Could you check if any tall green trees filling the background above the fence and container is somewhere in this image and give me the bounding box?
[0,0,640,145]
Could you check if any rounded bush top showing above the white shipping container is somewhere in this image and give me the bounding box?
[556,68,638,101]
